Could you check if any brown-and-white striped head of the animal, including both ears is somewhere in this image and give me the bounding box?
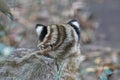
[35,19,80,59]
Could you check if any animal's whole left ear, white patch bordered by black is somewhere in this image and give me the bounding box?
[35,24,47,41]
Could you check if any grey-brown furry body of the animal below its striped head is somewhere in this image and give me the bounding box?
[0,49,80,80]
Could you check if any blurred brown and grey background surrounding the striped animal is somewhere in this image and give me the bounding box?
[0,0,120,80]
